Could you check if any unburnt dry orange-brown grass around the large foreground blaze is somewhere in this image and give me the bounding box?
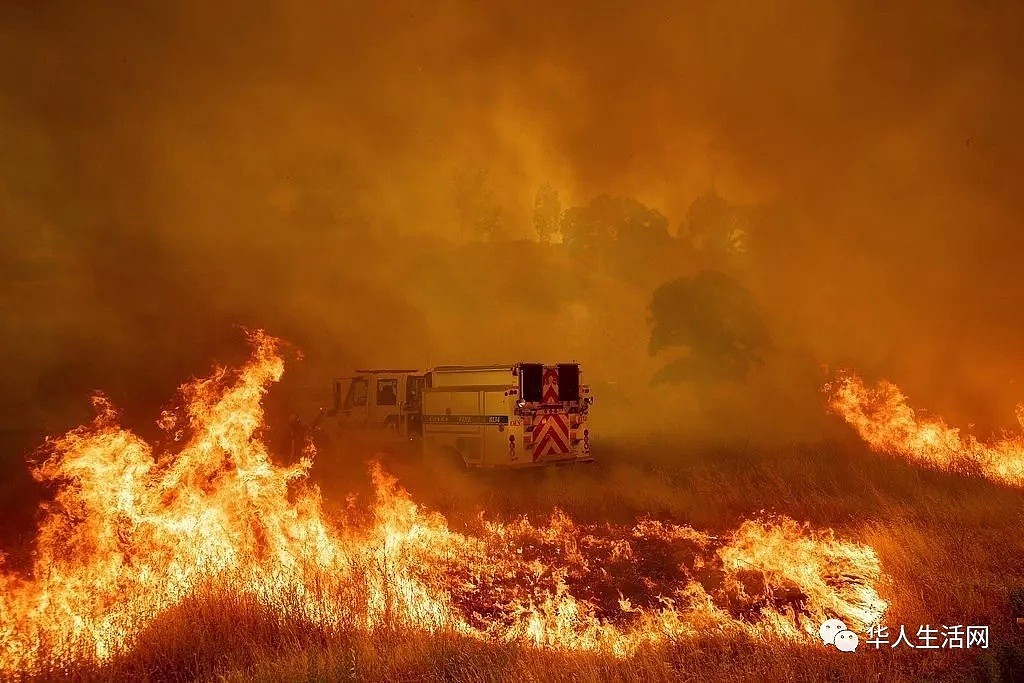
[8,430,1024,681]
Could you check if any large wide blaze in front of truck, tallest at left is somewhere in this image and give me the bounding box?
[0,332,886,673]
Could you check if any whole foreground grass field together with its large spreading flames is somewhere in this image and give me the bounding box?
[0,334,1021,680]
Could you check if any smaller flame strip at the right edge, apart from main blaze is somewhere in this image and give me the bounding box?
[824,371,1024,487]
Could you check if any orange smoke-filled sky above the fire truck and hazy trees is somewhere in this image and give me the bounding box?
[0,2,1024,436]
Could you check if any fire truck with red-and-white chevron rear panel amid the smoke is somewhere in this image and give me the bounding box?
[329,362,594,468]
